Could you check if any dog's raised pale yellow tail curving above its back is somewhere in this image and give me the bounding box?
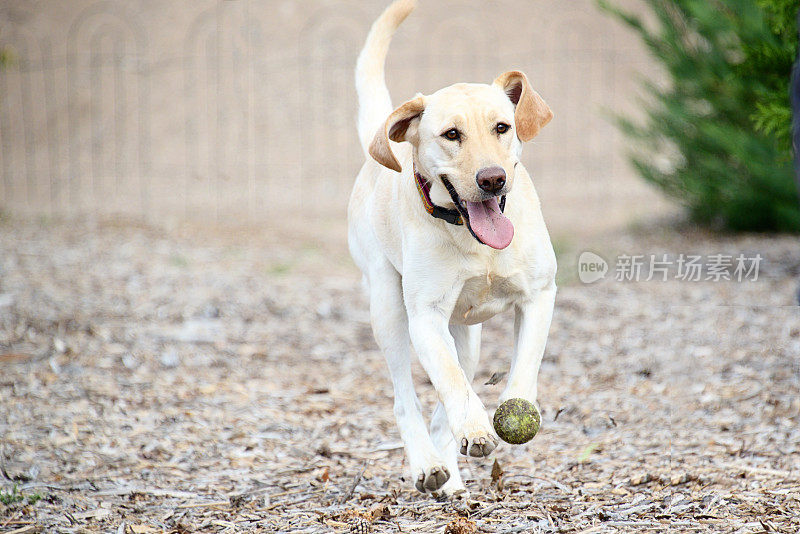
[356,0,417,152]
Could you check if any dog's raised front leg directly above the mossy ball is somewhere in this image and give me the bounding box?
[500,283,556,403]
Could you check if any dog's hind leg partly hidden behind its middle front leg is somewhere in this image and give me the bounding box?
[431,324,481,498]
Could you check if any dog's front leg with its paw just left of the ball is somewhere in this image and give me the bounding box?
[409,305,497,456]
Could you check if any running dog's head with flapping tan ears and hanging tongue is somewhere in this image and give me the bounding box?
[369,71,553,248]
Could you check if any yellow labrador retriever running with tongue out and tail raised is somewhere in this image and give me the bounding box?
[348,0,556,502]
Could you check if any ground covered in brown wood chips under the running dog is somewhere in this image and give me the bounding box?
[0,216,800,534]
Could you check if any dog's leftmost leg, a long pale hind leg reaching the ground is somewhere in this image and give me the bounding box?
[368,263,450,492]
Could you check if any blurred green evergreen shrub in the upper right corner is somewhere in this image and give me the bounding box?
[599,0,800,232]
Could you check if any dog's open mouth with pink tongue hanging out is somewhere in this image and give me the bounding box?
[442,176,514,249]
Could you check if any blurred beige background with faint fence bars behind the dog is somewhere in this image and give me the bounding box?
[0,0,656,234]
